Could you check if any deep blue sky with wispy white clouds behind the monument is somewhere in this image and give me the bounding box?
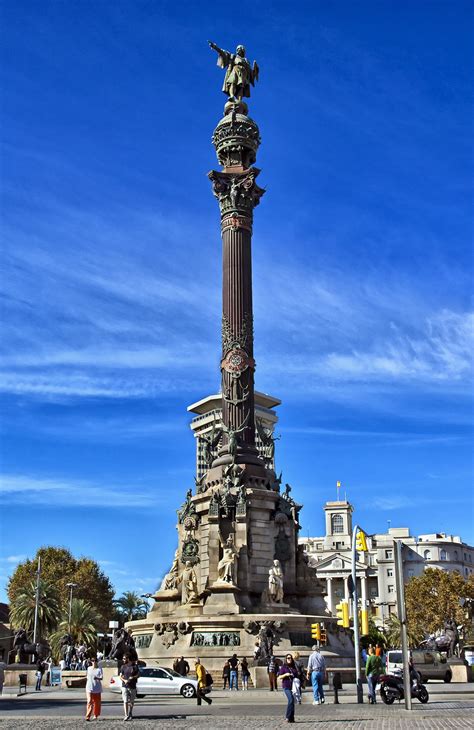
[0,0,474,600]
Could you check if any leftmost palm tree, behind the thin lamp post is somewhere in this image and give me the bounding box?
[10,578,61,637]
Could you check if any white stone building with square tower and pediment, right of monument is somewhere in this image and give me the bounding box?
[299,501,474,627]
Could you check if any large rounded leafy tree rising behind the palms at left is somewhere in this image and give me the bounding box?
[7,546,114,628]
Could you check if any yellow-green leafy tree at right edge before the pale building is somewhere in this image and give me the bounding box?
[405,568,474,638]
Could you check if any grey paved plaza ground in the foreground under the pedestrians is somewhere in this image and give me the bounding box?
[0,683,474,730]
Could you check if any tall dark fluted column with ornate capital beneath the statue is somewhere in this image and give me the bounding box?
[209,102,264,466]
